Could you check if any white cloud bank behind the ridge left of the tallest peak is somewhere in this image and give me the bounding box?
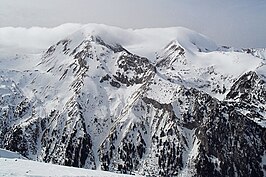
[0,24,82,53]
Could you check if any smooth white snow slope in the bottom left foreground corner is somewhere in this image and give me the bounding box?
[0,149,139,177]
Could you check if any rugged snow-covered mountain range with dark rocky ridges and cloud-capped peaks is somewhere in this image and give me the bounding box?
[0,24,266,177]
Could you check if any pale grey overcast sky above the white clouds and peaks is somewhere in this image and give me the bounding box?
[0,0,266,47]
